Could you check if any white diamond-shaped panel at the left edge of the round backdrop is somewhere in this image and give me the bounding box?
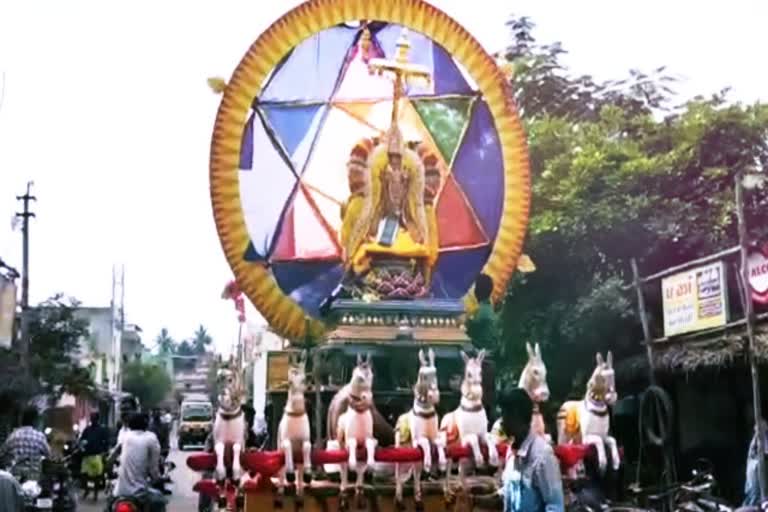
[238,108,296,258]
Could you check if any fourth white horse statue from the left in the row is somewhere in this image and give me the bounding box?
[395,349,446,506]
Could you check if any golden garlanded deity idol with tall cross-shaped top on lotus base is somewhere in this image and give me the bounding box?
[341,29,440,299]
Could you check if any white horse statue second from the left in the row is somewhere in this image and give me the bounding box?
[277,351,312,496]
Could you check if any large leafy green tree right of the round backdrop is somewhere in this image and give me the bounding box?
[497,19,768,398]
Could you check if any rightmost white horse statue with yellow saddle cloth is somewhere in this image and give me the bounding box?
[557,352,620,471]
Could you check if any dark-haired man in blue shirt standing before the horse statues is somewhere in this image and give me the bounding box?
[500,389,565,512]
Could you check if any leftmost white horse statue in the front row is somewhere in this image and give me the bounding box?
[213,368,247,482]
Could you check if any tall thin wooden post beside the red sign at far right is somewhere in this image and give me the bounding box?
[735,171,768,501]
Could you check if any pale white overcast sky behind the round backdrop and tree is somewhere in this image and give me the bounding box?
[0,0,768,351]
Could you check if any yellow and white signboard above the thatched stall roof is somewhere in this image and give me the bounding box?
[661,262,728,337]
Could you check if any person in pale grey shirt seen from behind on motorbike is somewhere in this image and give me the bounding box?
[109,413,166,512]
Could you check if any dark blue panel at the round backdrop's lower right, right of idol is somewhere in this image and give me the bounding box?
[432,245,491,299]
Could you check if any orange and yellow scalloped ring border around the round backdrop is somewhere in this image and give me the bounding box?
[210,0,531,340]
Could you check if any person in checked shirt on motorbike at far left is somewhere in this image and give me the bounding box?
[0,407,51,480]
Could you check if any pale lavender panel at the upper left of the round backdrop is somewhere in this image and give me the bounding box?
[259,26,358,103]
